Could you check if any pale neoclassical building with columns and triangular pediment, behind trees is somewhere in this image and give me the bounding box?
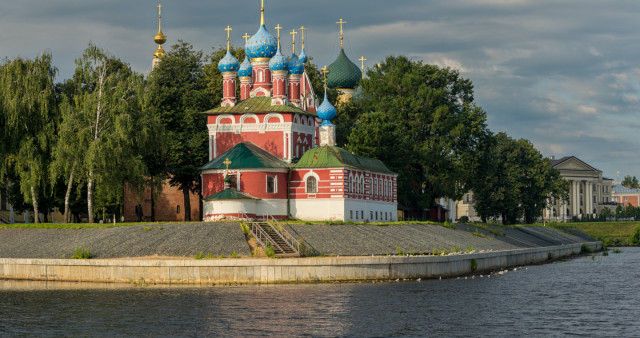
[543,156,615,221]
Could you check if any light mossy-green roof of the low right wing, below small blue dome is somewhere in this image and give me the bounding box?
[294,146,393,173]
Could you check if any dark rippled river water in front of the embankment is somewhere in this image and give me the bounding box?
[0,248,640,337]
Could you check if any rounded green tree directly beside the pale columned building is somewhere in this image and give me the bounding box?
[471,133,569,224]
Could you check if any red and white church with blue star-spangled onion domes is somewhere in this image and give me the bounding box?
[201,8,397,221]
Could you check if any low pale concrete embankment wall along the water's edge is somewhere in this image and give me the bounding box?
[0,242,602,284]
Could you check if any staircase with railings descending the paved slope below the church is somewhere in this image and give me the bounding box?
[247,220,300,257]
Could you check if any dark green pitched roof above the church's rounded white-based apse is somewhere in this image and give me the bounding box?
[200,142,289,170]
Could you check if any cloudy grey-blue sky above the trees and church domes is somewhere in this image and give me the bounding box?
[0,0,640,182]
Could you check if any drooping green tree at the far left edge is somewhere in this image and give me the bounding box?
[0,54,57,223]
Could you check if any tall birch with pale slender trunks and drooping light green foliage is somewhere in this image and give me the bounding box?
[52,44,153,223]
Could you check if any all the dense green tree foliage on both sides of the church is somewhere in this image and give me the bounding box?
[0,46,568,223]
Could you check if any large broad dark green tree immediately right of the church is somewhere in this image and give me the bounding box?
[344,56,488,208]
